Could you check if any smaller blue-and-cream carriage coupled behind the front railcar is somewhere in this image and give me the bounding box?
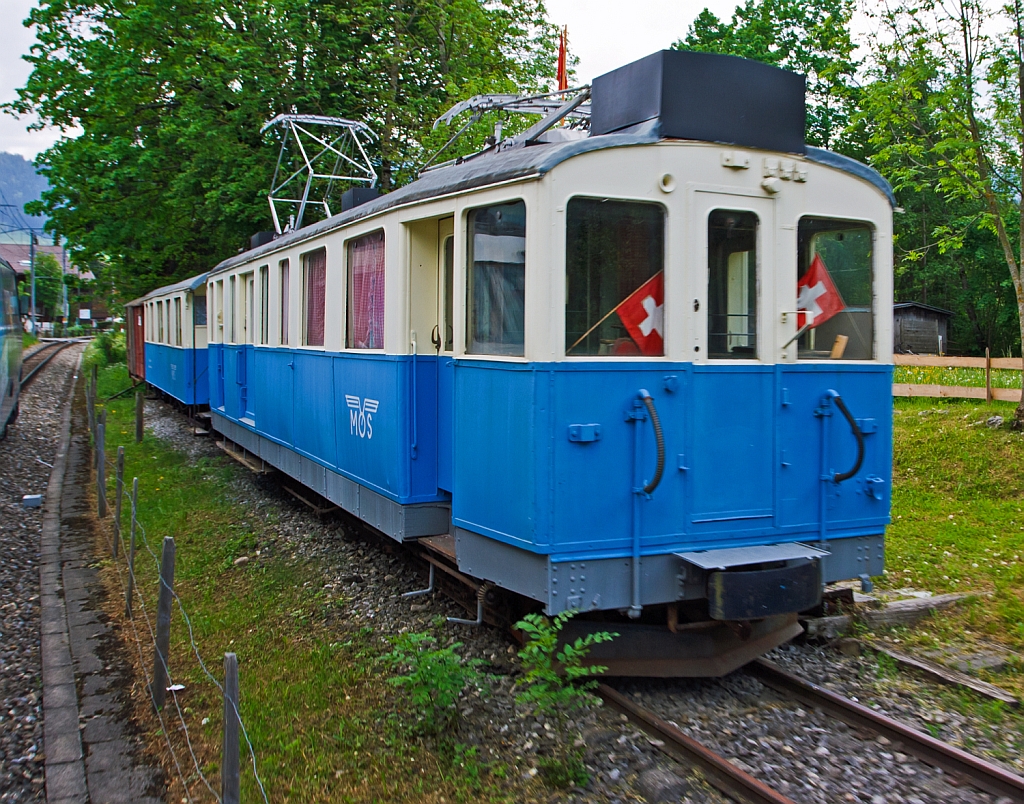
[137,273,210,407]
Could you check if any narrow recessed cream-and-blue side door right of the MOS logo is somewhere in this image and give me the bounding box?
[432,218,455,492]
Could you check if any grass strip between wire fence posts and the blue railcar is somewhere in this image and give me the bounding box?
[91,365,522,804]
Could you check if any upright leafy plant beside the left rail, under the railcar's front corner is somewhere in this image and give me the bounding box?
[516,611,618,788]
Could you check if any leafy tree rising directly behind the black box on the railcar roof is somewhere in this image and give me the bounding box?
[673,0,860,156]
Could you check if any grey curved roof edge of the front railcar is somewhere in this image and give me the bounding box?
[209,120,896,278]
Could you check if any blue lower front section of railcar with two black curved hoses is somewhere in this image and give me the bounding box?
[453,362,892,610]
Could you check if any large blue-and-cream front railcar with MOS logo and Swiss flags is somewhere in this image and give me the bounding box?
[208,52,893,675]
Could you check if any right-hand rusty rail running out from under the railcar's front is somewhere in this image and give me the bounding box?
[746,659,1024,802]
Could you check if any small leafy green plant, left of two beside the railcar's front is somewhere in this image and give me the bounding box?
[383,633,483,735]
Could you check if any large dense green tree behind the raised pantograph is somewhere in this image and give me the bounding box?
[6,0,555,300]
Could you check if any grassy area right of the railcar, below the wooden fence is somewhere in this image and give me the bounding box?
[880,398,1024,692]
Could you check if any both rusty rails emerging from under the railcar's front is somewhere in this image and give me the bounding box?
[597,659,1024,804]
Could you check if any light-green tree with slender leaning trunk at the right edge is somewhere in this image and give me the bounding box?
[864,0,1024,429]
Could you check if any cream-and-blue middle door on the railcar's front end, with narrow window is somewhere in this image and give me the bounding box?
[684,192,775,546]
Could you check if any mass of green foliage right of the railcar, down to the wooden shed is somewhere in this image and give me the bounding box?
[860,0,1024,364]
